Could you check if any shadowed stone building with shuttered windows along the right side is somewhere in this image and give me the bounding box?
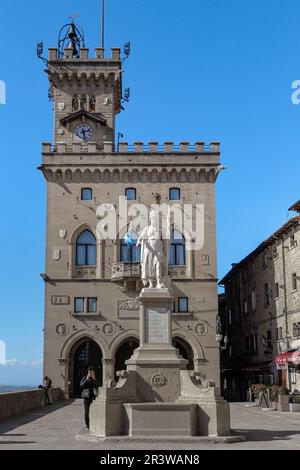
[219,203,300,400]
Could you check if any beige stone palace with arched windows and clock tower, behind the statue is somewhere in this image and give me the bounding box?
[40,39,221,396]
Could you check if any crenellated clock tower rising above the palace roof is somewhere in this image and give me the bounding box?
[47,26,122,150]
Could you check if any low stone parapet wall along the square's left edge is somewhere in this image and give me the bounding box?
[0,388,64,421]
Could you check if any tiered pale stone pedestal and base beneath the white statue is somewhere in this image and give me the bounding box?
[90,288,230,436]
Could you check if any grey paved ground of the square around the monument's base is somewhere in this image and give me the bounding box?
[0,400,300,450]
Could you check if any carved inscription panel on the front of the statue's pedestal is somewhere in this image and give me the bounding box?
[146,308,168,344]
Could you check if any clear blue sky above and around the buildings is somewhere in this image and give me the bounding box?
[0,0,300,385]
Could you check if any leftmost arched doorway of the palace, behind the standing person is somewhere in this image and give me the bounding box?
[69,338,103,397]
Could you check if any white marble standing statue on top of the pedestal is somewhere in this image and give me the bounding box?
[136,210,170,289]
